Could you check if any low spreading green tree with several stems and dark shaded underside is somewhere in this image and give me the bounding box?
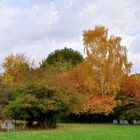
[8,86,65,128]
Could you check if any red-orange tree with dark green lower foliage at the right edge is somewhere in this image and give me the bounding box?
[114,74,140,120]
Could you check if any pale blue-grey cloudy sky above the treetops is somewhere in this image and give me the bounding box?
[0,0,140,73]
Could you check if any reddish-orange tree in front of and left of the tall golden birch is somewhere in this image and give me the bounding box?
[64,61,116,115]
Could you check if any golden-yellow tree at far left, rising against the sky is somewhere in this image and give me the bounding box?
[2,54,31,84]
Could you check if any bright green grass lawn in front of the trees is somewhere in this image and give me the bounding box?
[0,124,140,140]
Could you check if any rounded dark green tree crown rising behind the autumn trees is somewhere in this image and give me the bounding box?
[40,48,83,71]
